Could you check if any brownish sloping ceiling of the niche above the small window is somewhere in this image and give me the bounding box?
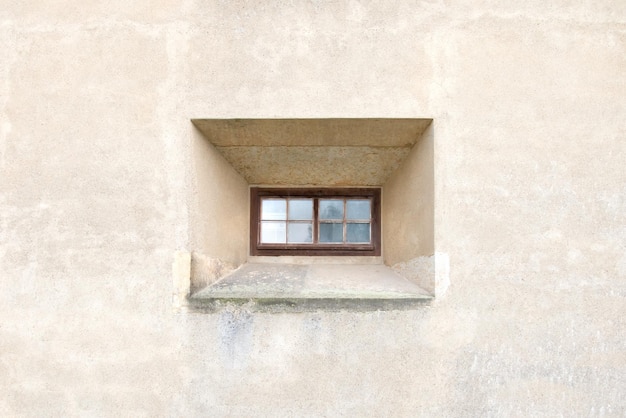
[191,118,432,186]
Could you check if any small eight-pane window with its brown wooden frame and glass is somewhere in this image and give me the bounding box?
[250,187,380,256]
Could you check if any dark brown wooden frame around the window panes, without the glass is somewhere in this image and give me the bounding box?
[250,187,381,256]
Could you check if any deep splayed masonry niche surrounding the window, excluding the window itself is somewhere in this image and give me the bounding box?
[174,118,438,312]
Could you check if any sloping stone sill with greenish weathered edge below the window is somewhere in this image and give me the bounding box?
[188,257,432,312]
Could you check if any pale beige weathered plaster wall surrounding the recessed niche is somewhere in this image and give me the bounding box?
[0,0,626,417]
